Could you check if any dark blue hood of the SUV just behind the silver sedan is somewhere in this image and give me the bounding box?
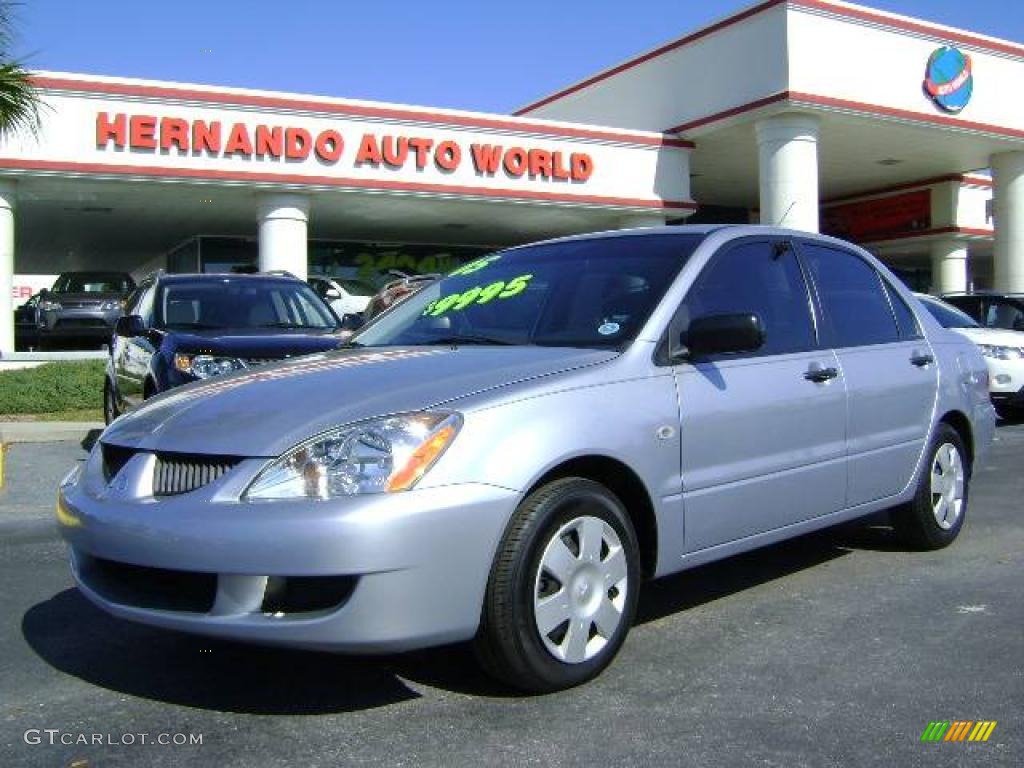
[174,328,344,358]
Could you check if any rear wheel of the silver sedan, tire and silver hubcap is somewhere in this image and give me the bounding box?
[892,422,971,550]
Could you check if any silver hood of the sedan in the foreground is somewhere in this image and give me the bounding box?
[101,346,616,457]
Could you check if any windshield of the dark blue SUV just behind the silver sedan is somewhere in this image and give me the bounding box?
[156,278,338,330]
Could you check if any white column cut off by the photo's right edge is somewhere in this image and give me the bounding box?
[991,152,1024,293]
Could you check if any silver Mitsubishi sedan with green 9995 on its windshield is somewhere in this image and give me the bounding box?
[57,226,994,691]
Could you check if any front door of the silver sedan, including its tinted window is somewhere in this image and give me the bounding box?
[670,239,846,553]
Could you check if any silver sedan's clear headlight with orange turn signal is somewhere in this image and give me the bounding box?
[245,412,462,499]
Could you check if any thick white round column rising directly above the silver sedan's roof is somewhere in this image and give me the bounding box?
[756,113,818,232]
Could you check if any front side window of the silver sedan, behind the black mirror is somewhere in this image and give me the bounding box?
[673,241,816,354]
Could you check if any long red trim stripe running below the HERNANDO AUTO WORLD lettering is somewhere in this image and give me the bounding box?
[0,158,696,210]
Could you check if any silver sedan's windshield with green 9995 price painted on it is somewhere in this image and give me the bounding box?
[354,233,703,347]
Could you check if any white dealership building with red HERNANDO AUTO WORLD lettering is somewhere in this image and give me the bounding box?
[0,0,1024,353]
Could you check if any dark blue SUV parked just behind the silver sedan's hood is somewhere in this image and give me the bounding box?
[103,274,341,424]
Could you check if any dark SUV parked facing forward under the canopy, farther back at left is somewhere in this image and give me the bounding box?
[36,272,135,348]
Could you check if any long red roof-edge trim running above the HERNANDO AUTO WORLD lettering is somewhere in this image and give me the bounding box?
[32,76,693,148]
